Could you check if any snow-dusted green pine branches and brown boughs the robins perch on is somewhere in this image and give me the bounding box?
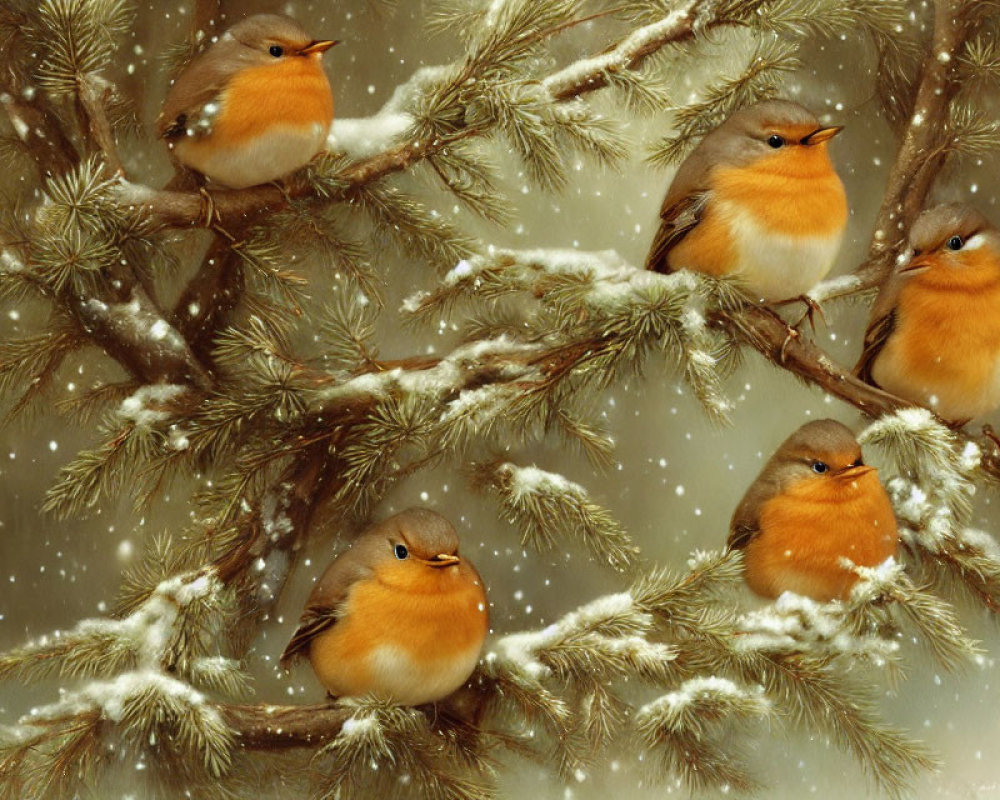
[0,0,1000,798]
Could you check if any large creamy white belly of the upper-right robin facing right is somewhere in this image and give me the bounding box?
[726,203,844,303]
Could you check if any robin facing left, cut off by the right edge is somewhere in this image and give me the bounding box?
[855,204,1000,426]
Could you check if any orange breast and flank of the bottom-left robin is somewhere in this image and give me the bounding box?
[309,562,489,695]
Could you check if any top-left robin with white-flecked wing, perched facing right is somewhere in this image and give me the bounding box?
[157,14,337,189]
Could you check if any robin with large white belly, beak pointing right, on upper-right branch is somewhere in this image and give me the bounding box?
[646,100,847,302]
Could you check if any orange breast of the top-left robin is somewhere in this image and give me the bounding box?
[212,56,333,145]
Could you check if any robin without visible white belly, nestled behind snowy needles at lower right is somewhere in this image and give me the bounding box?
[728,419,899,602]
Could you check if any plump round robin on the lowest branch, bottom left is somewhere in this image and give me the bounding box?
[281,508,489,705]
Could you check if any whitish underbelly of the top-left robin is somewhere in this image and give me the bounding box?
[174,123,328,189]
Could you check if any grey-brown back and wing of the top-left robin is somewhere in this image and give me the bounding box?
[156,42,246,140]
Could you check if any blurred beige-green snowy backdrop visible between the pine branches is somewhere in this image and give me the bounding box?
[0,0,1000,800]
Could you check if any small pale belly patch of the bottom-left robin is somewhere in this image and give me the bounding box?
[368,645,481,706]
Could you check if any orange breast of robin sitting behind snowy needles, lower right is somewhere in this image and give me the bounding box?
[745,470,898,601]
